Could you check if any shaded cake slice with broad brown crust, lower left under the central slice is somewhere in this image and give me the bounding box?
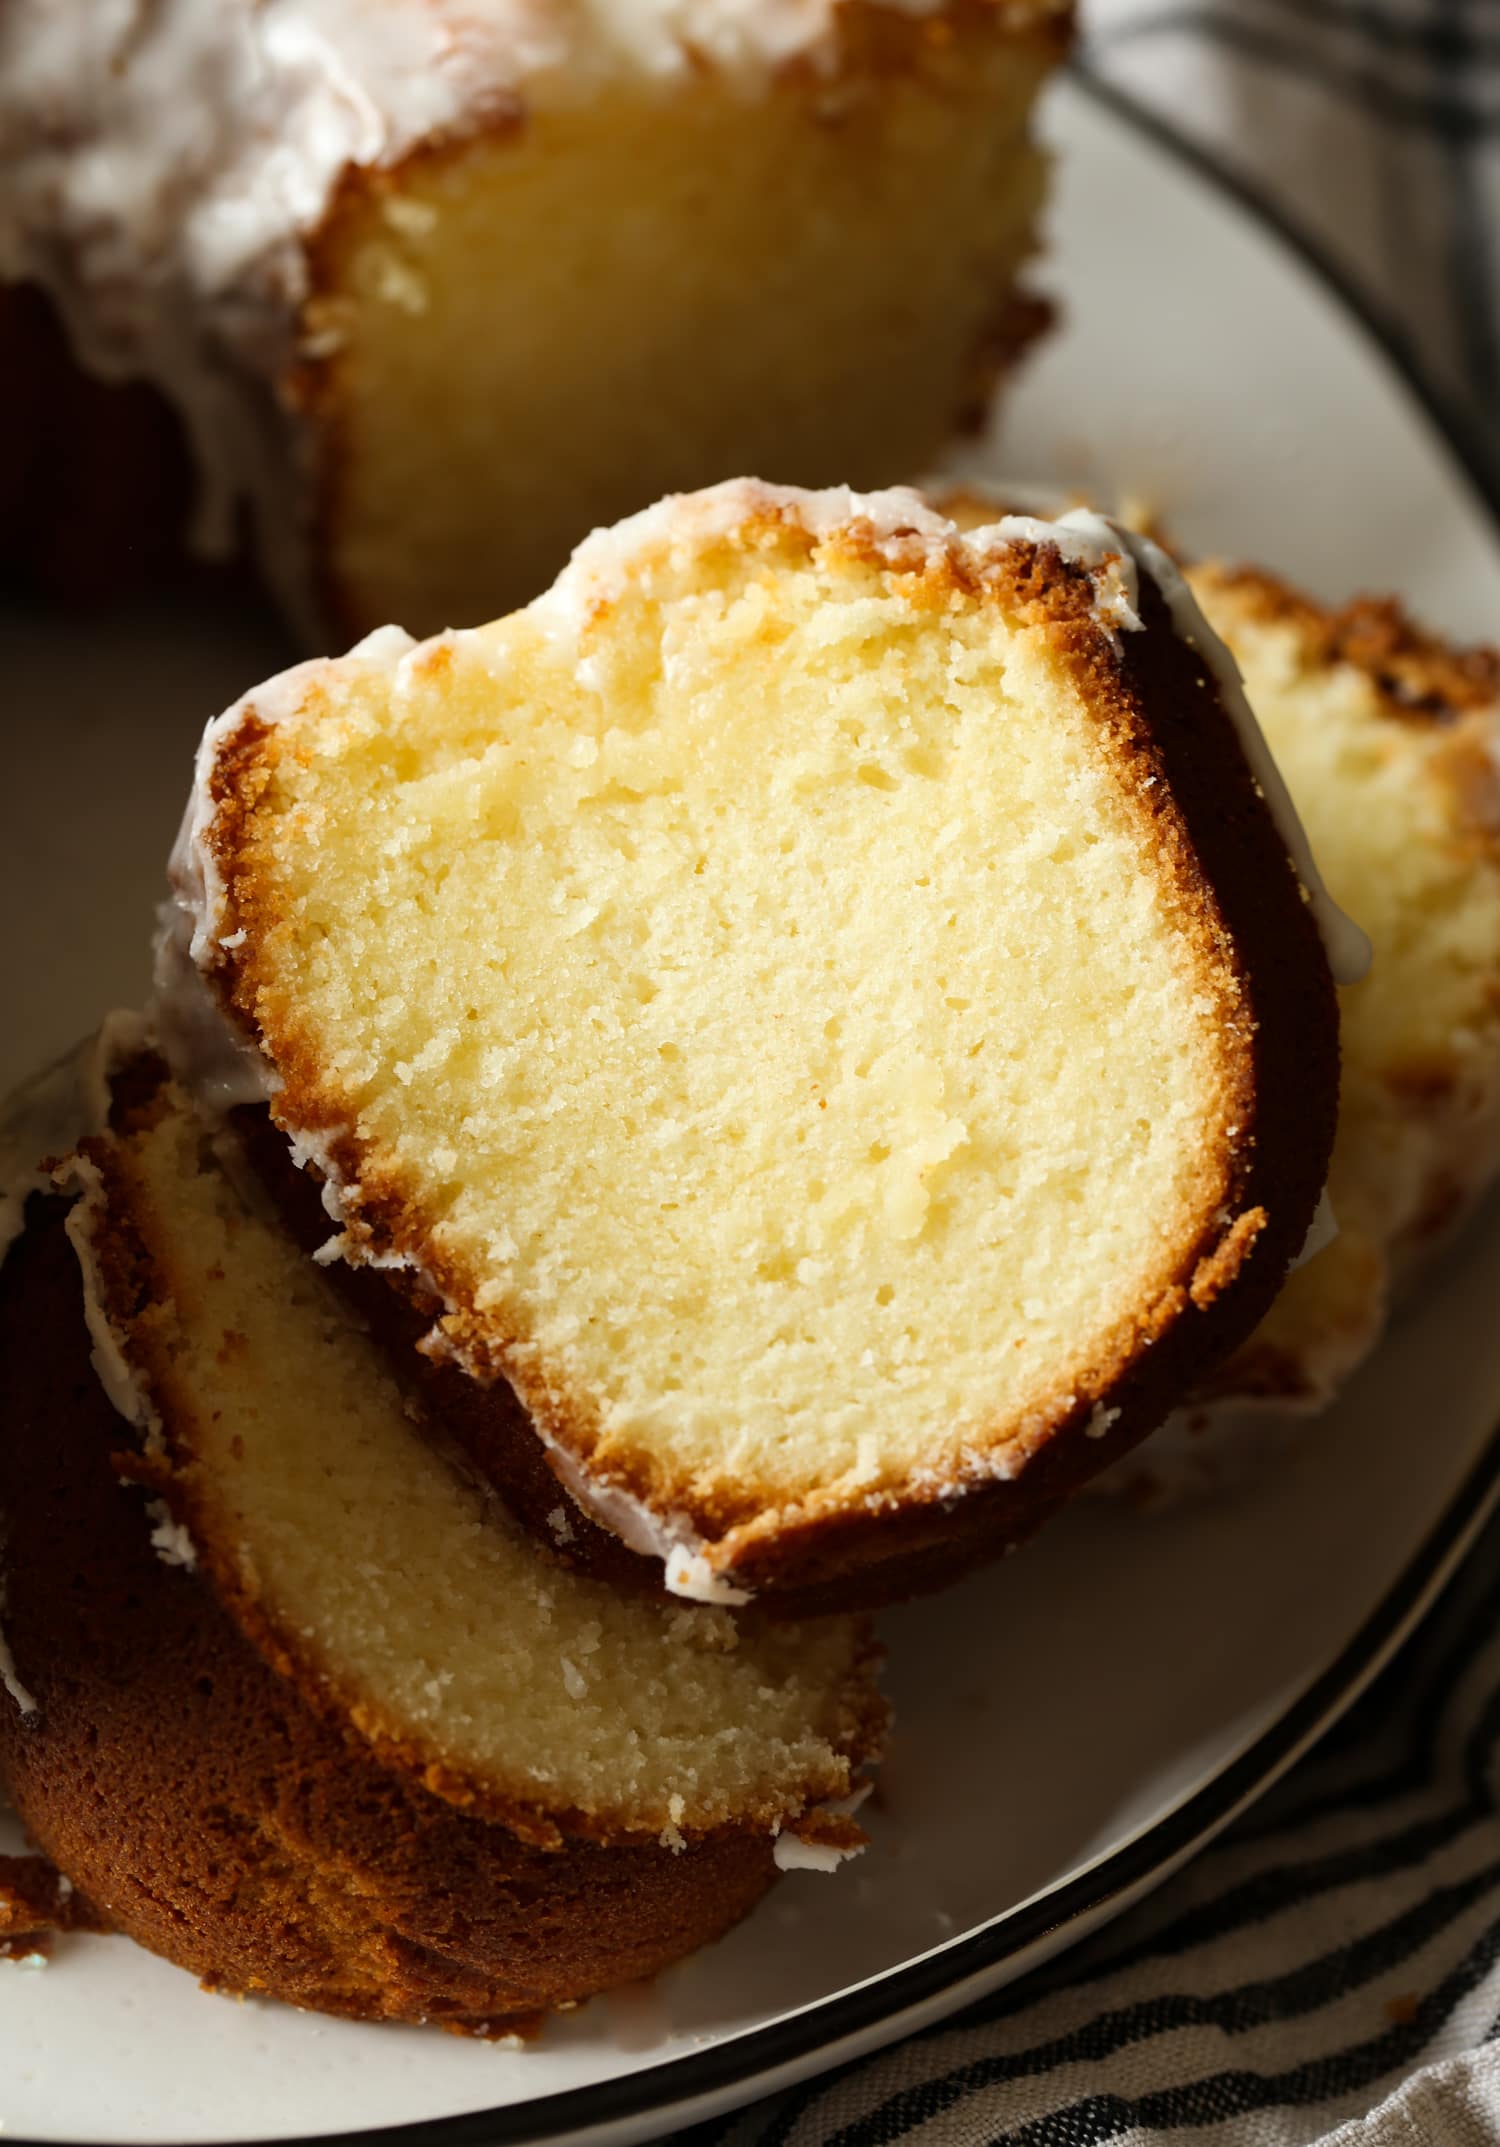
[0,1061,884,2033]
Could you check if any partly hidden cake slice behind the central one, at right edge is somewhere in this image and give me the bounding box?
[940,490,1500,1494]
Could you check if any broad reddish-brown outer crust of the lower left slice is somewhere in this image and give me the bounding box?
[0,1200,798,2033]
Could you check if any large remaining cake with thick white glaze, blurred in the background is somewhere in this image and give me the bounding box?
[0,0,1069,648]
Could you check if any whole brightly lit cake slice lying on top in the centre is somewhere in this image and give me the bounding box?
[157,481,1348,1600]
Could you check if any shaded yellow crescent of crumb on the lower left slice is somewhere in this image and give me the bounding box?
[111,1097,871,1831]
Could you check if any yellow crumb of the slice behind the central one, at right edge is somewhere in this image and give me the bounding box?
[1193,569,1500,1400]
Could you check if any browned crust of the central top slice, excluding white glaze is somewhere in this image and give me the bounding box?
[206,507,1337,1615]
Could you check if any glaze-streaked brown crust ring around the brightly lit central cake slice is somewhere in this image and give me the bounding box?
[159,481,1363,1608]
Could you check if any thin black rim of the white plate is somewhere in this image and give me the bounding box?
[6,56,1500,2147]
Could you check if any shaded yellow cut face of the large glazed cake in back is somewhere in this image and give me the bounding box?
[305,29,1062,633]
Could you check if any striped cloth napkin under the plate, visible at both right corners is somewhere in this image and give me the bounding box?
[678,0,1500,2147]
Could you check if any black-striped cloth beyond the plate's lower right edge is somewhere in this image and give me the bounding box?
[676,1522,1500,2147]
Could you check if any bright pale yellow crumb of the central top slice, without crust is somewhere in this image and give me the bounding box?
[236,526,1242,1505]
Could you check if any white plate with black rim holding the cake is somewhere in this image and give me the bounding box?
[0,86,1500,2147]
